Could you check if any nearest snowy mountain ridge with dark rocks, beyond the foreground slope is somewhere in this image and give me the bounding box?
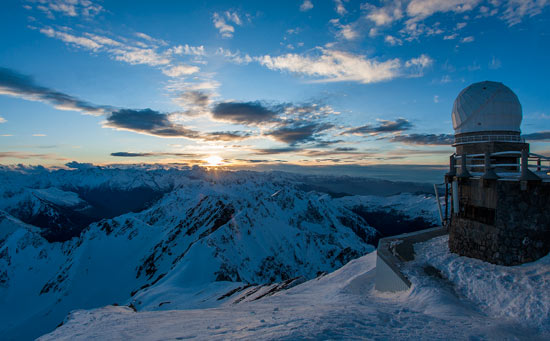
[0,169,384,338]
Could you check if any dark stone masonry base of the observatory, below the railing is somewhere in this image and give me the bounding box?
[449,179,550,265]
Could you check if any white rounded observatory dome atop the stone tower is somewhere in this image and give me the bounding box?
[452,81,522,135]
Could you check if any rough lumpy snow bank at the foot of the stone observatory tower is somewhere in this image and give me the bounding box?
[411,236,550,332]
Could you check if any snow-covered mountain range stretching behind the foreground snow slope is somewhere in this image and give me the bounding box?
[0,165,437,339]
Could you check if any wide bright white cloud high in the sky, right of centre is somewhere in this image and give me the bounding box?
[257,48,431,84]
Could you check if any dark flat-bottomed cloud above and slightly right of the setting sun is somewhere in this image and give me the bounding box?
[212,101,280,124]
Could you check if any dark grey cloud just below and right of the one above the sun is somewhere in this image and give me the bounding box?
[265,121,333,145]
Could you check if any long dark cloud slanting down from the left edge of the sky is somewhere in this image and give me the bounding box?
[0,67,109,115]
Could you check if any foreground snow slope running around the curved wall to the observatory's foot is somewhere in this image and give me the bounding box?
[39,243,550,341]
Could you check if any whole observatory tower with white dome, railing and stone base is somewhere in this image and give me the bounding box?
[445,81,550,265]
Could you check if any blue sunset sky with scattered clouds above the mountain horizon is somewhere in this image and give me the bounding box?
[0,0,550,178]
